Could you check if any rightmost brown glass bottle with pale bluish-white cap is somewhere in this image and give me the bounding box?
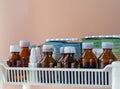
[98,42,117,68]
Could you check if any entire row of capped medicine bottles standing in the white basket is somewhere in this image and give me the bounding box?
[7,41,117,68]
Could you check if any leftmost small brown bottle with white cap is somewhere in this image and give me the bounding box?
[7,45,20,67]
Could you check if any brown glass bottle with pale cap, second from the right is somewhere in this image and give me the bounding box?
[80,42,98,68]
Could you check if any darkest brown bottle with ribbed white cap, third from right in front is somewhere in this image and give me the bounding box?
[61,46,78,68]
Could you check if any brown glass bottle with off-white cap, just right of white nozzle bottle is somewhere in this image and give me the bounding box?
[38,45,57,68]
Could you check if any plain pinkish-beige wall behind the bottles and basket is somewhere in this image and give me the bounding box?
[0,0,120,89]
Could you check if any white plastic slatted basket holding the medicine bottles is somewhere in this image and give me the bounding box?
[0,61,120,89]
